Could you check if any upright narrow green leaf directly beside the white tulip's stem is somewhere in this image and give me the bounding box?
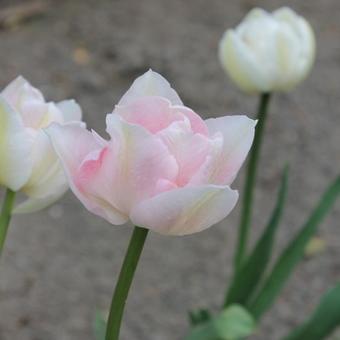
[225,167,288,306]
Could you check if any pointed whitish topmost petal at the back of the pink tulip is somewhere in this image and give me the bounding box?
[118,70,183,105]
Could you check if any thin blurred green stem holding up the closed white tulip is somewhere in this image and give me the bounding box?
[234,93,270,272]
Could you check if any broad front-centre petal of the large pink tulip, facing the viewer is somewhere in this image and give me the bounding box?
[102,114,178,215]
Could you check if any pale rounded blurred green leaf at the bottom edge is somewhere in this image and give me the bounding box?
[185,305,256,340]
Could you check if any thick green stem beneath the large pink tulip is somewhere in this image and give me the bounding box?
[105,226,148,340]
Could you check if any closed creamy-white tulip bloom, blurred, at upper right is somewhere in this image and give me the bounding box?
[219,7,315,93]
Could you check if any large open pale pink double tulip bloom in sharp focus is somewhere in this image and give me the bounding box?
[47,70,256,235]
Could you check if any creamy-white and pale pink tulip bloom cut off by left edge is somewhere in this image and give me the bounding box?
[0,77,81,213]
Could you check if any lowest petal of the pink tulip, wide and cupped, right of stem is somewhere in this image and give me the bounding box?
[130,185,238,235]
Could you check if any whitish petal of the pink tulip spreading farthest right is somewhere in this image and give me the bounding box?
[192,116,256,185]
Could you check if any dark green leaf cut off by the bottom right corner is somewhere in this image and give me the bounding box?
[285,284,340,340]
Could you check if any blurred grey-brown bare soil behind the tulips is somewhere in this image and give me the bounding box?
[0,0,340,340]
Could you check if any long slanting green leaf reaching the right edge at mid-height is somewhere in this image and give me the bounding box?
[247,176,340,319]
